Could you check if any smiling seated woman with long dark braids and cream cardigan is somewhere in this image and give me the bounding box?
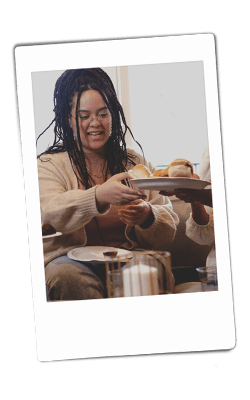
[38,68,179,300]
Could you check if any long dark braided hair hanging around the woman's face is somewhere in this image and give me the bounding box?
[37,68,143,189]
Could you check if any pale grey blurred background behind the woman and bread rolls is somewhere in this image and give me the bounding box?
[32,61,208,173]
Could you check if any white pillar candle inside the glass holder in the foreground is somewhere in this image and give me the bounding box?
[122,264,159,297]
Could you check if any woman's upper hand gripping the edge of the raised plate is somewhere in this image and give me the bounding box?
[96,172,146,212]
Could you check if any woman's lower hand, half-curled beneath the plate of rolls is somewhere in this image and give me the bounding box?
[118,199,154,228]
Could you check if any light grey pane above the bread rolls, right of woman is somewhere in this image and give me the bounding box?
[128,61,208,169]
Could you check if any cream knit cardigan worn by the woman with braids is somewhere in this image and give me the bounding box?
[38,149,179,265]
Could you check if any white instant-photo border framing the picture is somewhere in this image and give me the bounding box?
[14,33,236,362]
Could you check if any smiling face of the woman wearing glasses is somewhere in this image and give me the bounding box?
[69,89,111,152]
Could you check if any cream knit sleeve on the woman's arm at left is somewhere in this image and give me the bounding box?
[38,156,108,234]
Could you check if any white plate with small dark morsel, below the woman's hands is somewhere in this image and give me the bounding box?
[68,246,133,263]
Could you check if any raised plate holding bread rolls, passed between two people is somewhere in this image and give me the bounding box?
[130,176,211,191]
